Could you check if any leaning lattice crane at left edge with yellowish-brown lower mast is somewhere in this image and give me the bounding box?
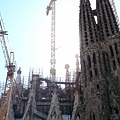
[0,20,15,120]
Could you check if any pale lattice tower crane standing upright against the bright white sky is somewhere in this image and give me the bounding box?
[46,0,56,81]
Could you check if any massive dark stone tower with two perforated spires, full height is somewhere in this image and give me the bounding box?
[79,0,120,120]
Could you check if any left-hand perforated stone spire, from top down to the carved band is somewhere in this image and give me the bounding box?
[79,0,98,48]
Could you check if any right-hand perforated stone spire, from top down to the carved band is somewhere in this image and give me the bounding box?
[96,0,119,40]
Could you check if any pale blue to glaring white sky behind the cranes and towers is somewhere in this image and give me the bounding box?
[0,0,120,85]
